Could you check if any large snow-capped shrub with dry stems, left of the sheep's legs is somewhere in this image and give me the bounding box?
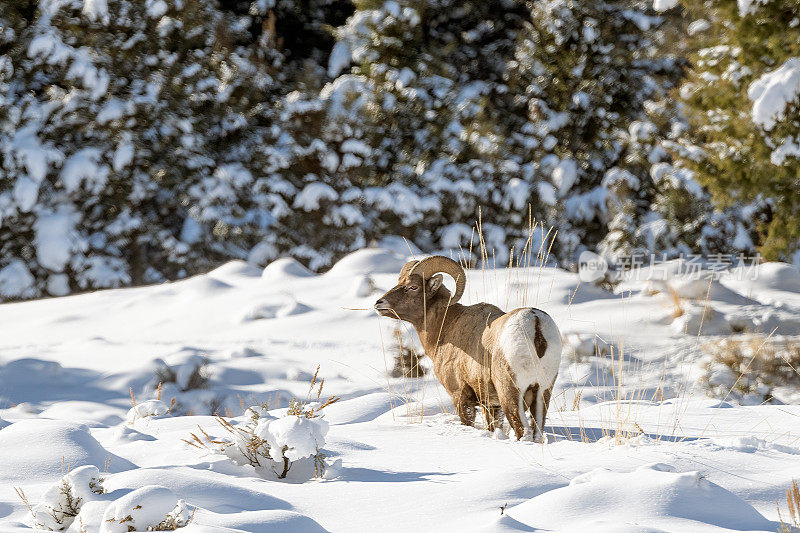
[190,397,338,479]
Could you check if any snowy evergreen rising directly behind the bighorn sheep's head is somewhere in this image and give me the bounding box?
[320,0,537,264]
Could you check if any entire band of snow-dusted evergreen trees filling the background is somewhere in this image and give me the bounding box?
[0,0,800,298]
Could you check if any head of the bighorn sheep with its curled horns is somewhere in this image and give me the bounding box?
[375,255,466,323]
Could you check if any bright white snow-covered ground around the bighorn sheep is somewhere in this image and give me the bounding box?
[0,249,800,532]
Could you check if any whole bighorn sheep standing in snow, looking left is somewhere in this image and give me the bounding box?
[375,256,561,442]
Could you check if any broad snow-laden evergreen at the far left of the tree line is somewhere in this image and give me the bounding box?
[0,0,278,294]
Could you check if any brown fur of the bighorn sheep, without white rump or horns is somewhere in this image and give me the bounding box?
[376,272,549,439]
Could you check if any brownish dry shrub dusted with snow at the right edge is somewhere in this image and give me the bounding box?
[701,336,800,404]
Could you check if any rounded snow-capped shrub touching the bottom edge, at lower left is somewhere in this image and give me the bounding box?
[100,485,192,533]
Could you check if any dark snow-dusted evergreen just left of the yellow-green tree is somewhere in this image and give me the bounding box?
[509,0,680,262]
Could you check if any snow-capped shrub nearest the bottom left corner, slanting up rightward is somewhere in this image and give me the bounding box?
[30,465,105,531]
